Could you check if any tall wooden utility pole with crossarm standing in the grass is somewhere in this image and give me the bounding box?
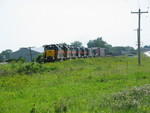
[131,9,148,65]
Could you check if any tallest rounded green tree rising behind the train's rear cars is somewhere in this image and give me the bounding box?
[87,37,112,49]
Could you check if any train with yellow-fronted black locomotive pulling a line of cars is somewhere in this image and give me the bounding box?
[43,44,106,63]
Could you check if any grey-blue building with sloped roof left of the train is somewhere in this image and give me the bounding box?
[10,48,40,62]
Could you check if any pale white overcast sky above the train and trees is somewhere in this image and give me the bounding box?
[0,0,150,52]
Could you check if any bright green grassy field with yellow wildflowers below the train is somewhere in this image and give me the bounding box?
[0,56,150,113]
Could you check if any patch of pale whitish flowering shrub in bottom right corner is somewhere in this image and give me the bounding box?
[101,84,150,112]
